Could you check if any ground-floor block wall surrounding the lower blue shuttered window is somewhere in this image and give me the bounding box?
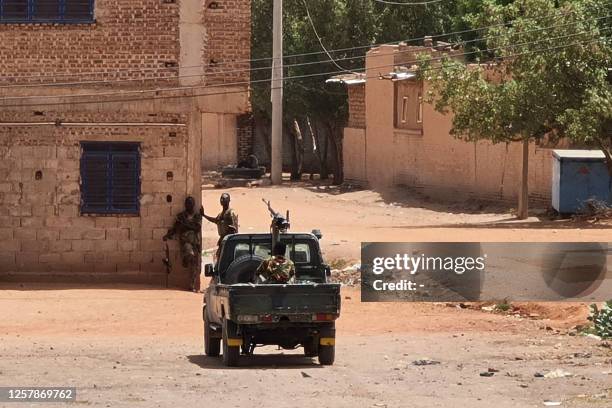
[0,111,188,281]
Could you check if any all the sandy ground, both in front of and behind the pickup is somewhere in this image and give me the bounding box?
[0,184,612,408]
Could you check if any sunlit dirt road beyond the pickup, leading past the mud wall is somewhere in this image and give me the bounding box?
[202,183,612,261]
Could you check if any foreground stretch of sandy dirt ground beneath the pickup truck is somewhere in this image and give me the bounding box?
[0,286,612,408]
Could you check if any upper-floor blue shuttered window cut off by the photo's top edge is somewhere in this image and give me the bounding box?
[0,0,94,23]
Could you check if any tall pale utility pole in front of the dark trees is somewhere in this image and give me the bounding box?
[270,0,283,184]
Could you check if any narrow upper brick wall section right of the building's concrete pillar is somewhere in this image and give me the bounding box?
[203,0,251,86]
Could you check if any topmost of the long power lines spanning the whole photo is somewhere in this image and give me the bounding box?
[1,2,612,81]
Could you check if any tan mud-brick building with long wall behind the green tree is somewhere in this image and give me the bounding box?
[338,43,553,203]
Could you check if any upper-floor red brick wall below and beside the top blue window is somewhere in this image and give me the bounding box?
[0,0,180,86]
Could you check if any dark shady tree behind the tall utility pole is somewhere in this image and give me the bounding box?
[251,0,455,183]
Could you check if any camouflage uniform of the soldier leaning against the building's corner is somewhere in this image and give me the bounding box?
[166,211,202,268]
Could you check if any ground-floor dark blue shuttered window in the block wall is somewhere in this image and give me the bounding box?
[81,142,140,214]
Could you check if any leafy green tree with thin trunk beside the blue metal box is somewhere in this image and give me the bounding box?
[420,0,612,218]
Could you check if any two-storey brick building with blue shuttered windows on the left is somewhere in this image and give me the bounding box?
[0,0,251,284]
